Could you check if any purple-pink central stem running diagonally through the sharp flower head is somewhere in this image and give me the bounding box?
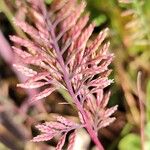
[47,20,104,150]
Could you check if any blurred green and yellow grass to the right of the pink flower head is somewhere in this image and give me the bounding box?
[87,0,150,150]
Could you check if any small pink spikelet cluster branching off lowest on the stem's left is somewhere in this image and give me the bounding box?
[32,116,81,150]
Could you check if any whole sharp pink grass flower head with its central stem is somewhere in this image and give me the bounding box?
[10,0,117,150]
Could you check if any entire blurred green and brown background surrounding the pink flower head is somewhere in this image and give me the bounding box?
[0,0,150,150]
